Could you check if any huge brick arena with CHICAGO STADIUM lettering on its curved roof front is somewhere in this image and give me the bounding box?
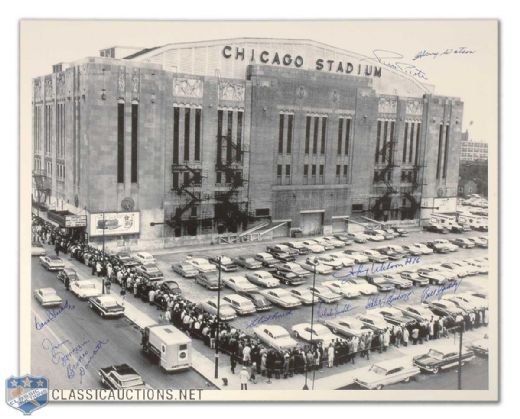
[33,38,463,248]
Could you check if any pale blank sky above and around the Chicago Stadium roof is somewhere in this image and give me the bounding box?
[20,20,498,142]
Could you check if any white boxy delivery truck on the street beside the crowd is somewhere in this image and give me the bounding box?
[141,325,191,372]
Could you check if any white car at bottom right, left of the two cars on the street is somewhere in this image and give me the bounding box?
[354,358,421,390]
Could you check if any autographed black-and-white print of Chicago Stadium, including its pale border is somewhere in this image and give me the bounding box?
[17,20,499,406]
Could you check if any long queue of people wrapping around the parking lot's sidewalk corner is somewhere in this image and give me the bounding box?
[32,216,488,388]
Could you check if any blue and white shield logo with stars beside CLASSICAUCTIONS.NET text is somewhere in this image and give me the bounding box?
[5,375,49,415]
